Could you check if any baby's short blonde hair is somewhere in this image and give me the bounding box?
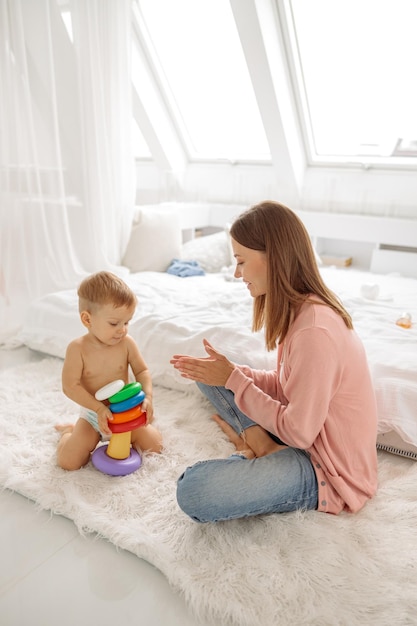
[77,272,137,313]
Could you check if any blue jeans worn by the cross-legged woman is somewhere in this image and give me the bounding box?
[177,383,318,522]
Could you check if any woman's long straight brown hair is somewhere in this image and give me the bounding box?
[230,201,353,350]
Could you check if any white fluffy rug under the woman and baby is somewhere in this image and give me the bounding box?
[0,359,417,626]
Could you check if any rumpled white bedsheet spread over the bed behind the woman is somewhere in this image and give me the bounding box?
[20,267,417,445]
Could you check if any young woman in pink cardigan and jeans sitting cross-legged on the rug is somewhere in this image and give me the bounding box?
[171,201,377,522]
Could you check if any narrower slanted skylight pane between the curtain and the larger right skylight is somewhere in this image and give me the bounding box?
[137,0,271,162]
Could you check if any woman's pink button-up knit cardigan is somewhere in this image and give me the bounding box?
[226,303,377,514]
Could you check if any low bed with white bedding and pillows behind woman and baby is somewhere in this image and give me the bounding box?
[16,204,417,458]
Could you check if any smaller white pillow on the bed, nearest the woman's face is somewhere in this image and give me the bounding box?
[181,230,233,272]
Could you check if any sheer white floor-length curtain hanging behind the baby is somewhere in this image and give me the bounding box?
[0,0,135,342]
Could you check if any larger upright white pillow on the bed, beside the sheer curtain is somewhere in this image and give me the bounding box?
[122,207,182,272]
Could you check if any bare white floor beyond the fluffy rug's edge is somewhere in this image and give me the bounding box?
[0,348,208,626]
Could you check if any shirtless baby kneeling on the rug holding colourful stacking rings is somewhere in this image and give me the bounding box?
[56,272,162,470]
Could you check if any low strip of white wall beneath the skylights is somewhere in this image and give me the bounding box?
[136,162,417,218]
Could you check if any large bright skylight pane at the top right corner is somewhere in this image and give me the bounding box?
[278,0,417,164]
